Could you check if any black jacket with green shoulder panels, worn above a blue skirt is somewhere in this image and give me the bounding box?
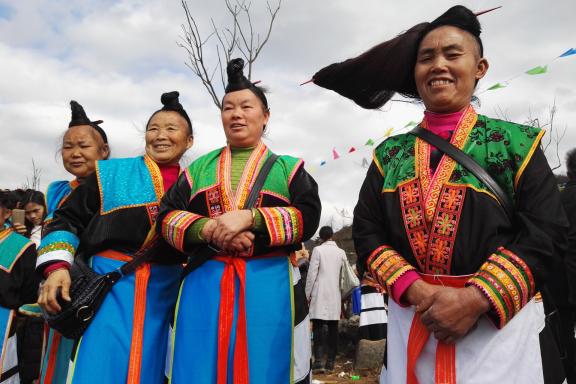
[157,143,320,256]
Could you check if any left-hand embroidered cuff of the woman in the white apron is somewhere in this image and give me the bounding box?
[366,245,416,294]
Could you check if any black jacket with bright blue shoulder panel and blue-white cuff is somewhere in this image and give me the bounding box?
[37,156,182,270]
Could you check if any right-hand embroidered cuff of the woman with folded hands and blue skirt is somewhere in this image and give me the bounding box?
[258,207,304,247]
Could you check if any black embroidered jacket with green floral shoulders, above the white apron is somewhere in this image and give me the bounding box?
[353,107,566,327]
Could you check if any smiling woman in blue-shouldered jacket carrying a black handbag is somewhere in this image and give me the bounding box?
[37,92,193,384]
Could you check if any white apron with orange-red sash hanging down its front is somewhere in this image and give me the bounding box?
[380,276,545,384]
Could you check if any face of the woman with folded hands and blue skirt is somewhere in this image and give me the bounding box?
[221,89,270,148]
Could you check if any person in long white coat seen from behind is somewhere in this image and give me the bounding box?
[306,227,348,371]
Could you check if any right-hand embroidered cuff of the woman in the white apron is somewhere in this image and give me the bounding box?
[466,247,536,328]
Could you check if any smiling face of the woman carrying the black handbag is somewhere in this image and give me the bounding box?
[146,111,194,165]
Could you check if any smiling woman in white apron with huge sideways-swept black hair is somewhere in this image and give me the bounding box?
[313,6,567,383]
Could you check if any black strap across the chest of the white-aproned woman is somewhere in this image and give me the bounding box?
[410,126,514,220]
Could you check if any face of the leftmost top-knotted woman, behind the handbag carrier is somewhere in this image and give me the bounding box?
[62,125,109,179]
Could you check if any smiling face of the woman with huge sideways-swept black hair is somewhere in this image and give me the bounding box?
[414,26,488,113]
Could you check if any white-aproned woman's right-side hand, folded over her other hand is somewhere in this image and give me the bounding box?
[416,286,490,344]
